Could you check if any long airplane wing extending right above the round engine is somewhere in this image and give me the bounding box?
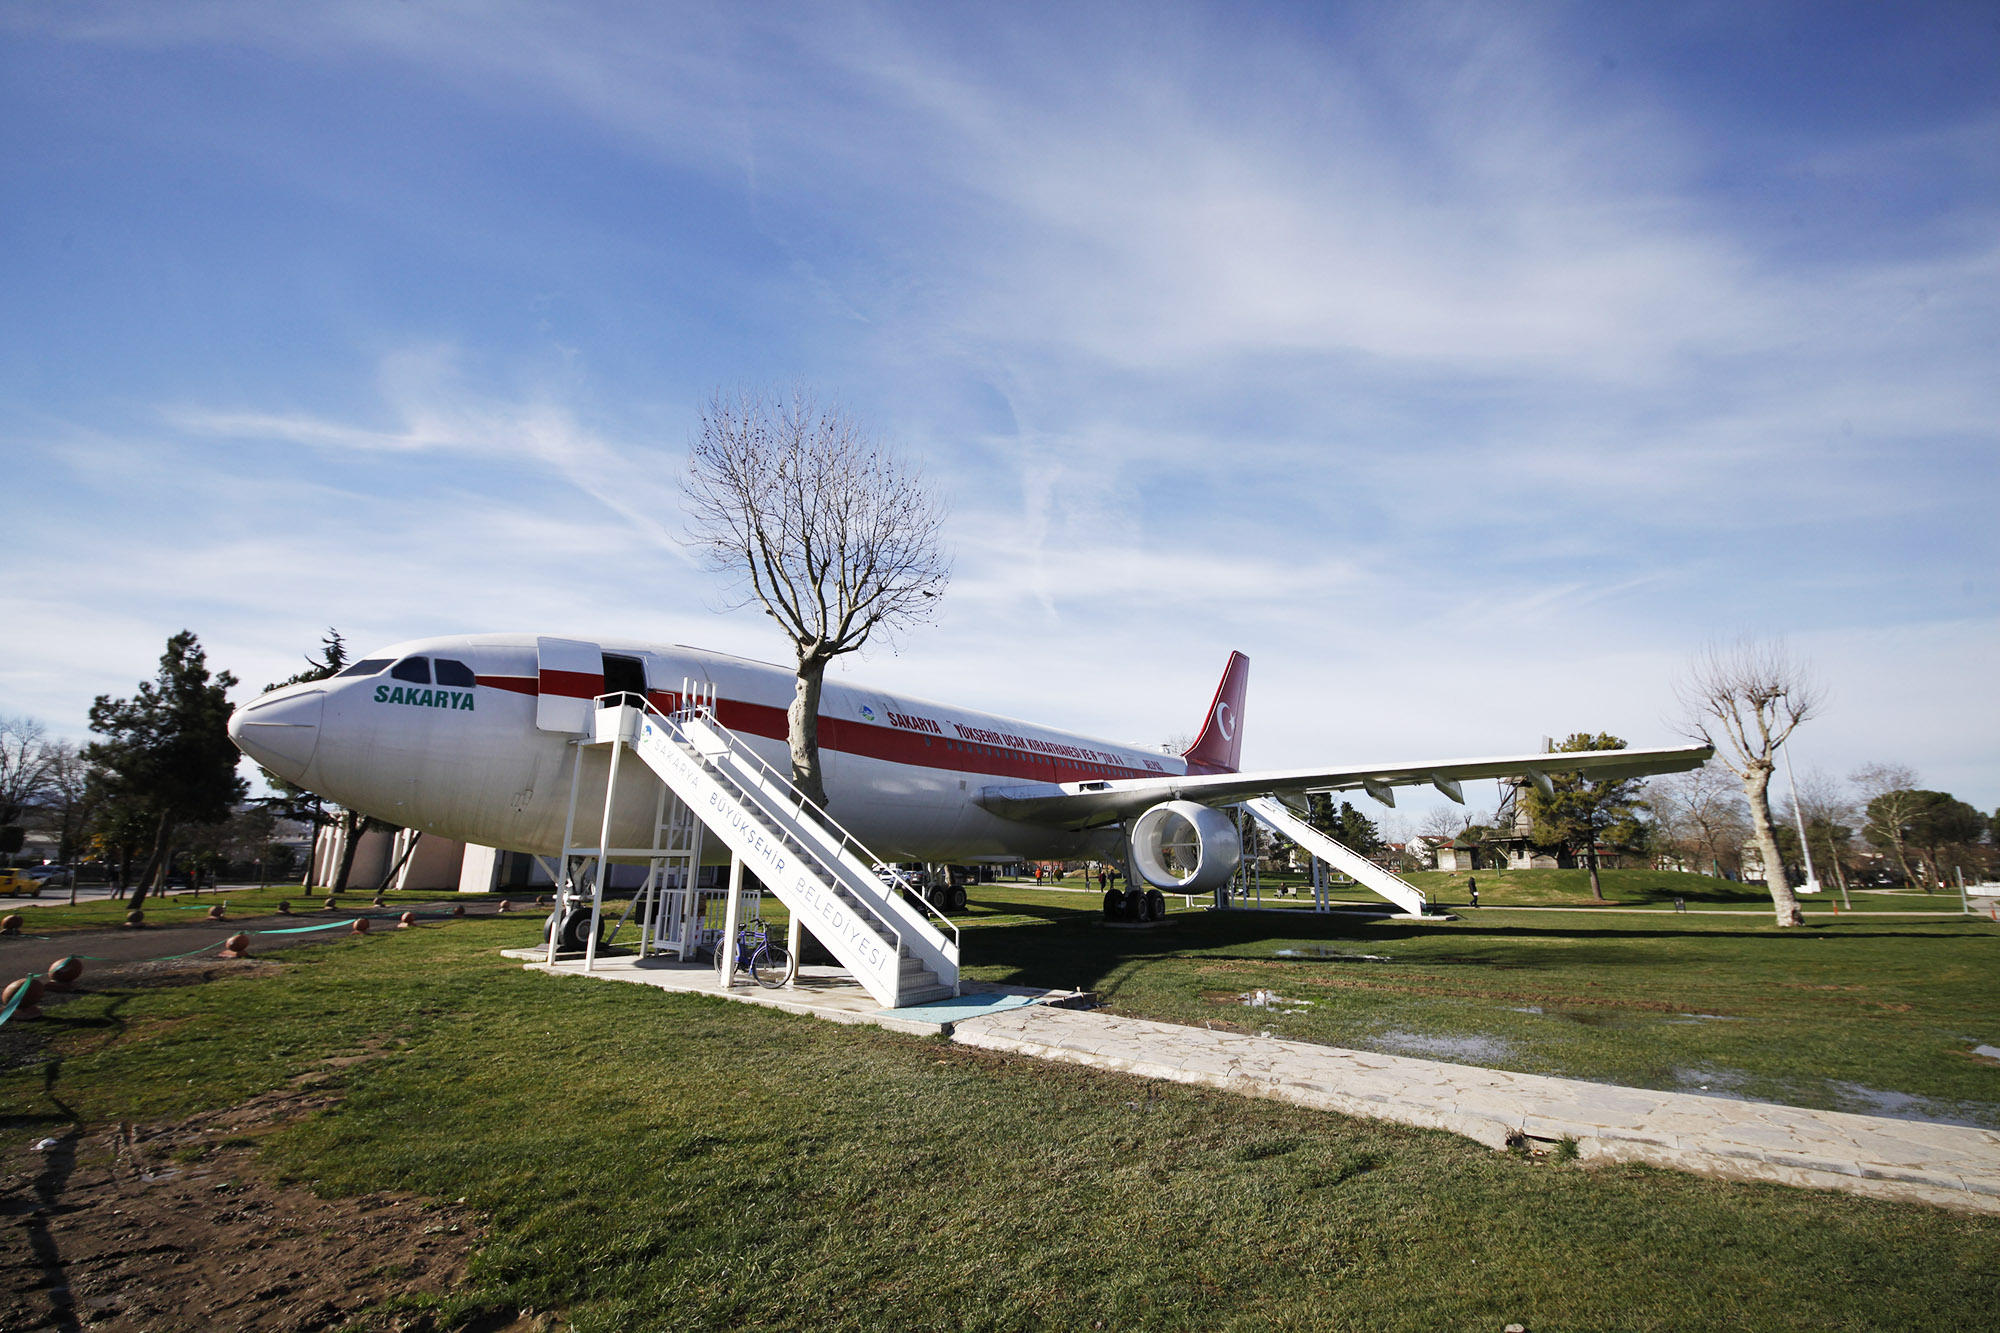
[976,745,1716,829]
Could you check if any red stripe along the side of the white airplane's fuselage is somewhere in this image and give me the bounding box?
[478,671,1170,783]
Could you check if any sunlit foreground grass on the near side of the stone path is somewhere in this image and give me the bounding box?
[0,912,2000,1333]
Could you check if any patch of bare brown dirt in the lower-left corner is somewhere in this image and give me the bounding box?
[0,961,540,1333]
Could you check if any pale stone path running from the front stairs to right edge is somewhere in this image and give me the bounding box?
[506,949,2000,1215]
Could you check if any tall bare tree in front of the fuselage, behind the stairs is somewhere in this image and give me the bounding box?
[686,388,950,805]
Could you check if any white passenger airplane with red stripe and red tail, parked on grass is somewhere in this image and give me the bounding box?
[228,634,1714,917]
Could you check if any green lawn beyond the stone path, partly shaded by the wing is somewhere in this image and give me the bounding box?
[964,877,2000,1127]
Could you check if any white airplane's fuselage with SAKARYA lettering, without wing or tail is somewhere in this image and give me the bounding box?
[230,634,1186,861]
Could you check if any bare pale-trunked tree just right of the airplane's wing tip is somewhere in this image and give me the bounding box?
[1676,638,1822,927]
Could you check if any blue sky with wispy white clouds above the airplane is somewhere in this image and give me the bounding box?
[0,0,2000,809]
